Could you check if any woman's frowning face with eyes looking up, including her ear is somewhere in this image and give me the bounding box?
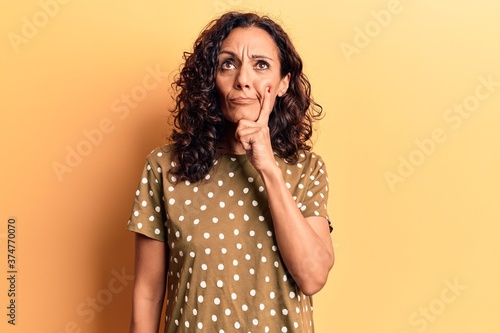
[215,27,290,123]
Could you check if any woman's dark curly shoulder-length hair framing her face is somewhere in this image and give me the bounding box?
[169,12,323,182]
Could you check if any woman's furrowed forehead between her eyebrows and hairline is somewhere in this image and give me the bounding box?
[221,27,278,57]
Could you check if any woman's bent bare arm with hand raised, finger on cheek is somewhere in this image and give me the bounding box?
[236,89,334,295]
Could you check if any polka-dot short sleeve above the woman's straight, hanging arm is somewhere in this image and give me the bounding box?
[127,155,166,242]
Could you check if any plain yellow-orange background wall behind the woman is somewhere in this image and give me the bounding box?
[0,0,500,333]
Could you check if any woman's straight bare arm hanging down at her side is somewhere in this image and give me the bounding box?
[130,233,168,333]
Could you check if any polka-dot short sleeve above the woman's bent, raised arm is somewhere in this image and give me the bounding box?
[302,153,333,232]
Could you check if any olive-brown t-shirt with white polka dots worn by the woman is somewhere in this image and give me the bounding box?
[127,145,331,333]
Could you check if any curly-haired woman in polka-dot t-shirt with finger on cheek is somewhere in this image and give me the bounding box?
[128,12,334,333]
